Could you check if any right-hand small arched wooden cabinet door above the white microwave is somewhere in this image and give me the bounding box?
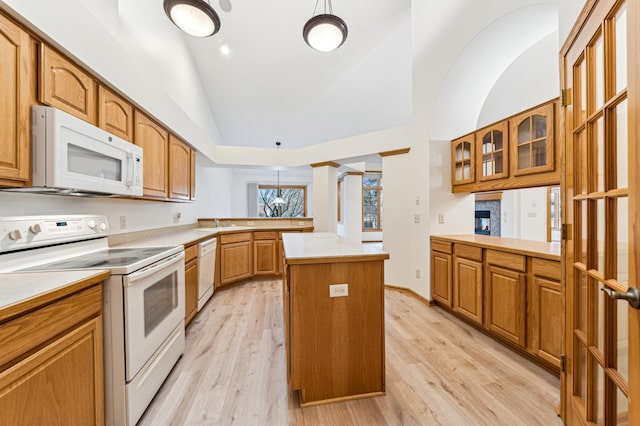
[98,86,133,142]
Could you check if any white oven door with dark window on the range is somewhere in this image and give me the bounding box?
[123,252,184,382]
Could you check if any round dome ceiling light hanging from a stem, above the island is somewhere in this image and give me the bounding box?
[302,0,348,52]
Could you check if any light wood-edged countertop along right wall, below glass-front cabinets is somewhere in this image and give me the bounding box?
[431,234,560,260]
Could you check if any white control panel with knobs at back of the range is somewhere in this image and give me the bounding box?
[0,215,109,253]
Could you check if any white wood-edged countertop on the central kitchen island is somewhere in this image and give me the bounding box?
[282,232,389,264]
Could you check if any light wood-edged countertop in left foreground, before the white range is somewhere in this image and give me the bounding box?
[0,270,109,318]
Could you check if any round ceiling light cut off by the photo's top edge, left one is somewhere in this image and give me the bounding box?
[164,0,220,37]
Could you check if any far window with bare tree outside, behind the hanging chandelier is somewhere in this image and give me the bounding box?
[257,185,307,217]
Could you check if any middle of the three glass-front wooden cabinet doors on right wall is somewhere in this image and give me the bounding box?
[476,120,509,181]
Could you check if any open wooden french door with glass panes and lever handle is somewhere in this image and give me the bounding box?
[561,0,640,425]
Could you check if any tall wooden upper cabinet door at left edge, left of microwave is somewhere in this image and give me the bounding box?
[0,15,35,186]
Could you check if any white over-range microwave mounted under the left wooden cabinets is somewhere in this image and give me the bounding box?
[9,106,143,196]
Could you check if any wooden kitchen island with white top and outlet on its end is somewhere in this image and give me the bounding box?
[282,233,389,407]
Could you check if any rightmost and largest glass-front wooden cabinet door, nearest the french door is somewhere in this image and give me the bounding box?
[510,103,555,176]
